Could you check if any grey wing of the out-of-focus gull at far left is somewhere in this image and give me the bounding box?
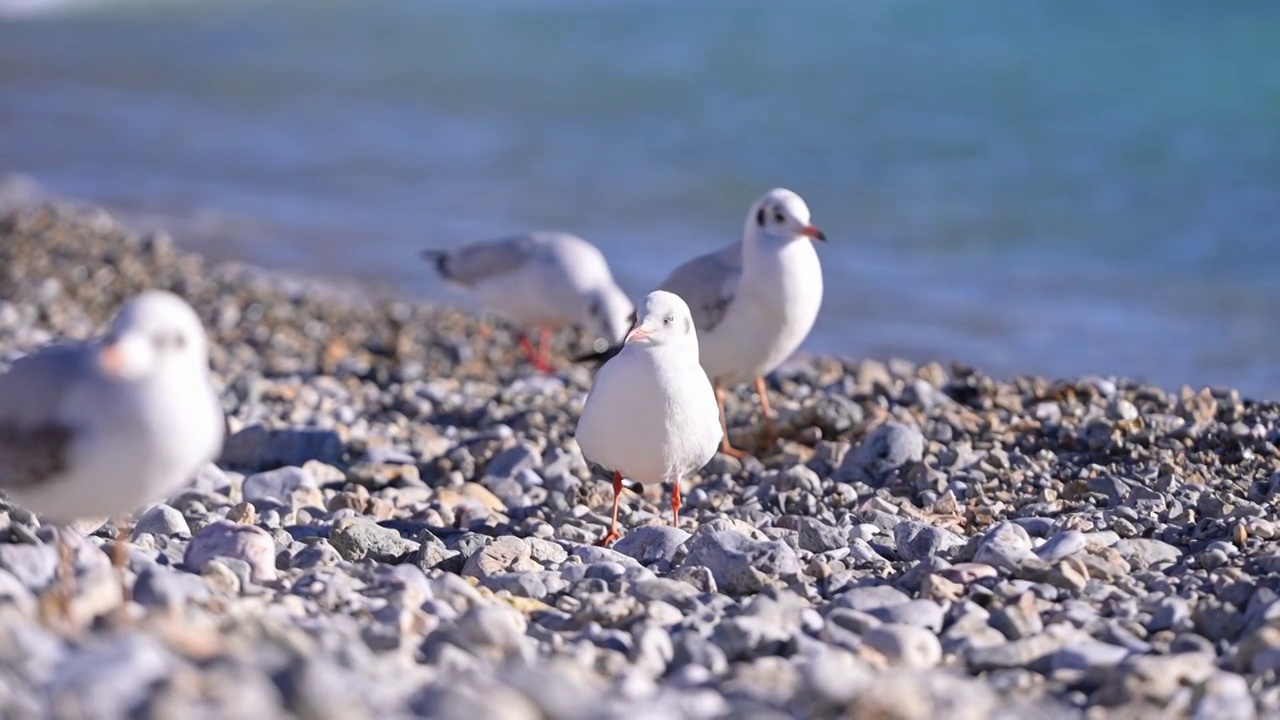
[0,345,88,489]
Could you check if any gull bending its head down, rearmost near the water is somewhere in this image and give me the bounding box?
[422,232,635,373]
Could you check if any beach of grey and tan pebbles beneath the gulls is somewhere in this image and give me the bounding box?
[0,196,1280,720]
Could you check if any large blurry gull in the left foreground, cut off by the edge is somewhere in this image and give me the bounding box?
[0,291,227,617]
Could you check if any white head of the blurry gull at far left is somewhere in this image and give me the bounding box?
[97,290,209,380]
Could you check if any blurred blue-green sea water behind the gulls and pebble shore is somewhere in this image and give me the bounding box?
[0,0,1280,397]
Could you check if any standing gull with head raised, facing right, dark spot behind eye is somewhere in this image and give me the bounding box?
[575,187,827,459]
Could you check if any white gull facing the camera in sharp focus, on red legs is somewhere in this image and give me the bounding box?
[576,290,723,546]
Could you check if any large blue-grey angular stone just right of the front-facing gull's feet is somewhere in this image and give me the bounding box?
[684,529,800,594]
